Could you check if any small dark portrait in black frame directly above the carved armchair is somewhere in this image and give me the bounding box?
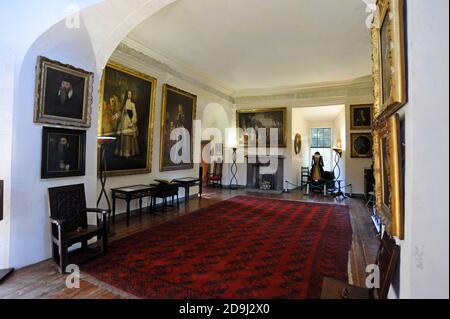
[41,127,86,179]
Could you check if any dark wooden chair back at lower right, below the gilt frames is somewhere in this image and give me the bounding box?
[376,233,400,299]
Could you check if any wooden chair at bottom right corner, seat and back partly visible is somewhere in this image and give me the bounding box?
[321,233,400,299]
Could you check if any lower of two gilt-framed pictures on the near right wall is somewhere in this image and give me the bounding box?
[374,114,404,239]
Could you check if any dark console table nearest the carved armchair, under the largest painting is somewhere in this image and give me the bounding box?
[111,185,155,227]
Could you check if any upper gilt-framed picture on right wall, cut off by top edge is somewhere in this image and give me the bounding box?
[372,0,407,121]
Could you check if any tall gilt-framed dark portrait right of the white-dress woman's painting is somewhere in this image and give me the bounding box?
[160,84,197,172]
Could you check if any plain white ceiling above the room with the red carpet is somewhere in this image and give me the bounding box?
[128,0,371,91]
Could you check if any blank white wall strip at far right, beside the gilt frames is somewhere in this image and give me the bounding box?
[392,0,449,299]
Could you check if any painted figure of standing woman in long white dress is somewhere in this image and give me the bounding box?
[115,90,140,158]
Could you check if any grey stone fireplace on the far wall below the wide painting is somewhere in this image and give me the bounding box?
[247,156,284,192]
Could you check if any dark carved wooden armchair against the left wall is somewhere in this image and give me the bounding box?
[48,184,110,273]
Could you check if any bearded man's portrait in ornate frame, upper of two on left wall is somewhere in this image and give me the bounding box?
[34,56,94,127]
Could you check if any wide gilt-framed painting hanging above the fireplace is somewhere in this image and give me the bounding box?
[236,107,287,148]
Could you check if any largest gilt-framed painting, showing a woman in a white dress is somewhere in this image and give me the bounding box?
[98,63,156,176]
